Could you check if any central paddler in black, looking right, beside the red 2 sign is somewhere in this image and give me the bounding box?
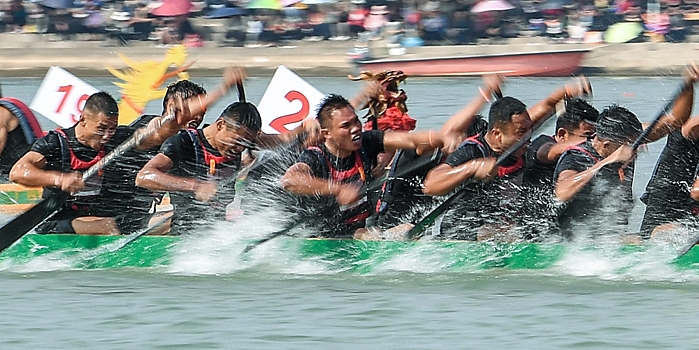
[282,95,443,238]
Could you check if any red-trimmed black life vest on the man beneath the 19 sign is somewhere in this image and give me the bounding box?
[49,128,106,200]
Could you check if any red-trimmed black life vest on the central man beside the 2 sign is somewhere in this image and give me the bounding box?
[308,146,371,225]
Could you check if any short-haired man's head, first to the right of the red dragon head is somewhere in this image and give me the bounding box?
[486,96,532,156]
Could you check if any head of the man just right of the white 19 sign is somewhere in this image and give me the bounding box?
[75,91,119,150]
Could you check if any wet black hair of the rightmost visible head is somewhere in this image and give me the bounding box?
[597,104,643,143]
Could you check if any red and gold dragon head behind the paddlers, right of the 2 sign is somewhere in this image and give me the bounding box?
[348,70,416,130]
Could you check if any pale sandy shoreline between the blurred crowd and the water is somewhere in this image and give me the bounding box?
[0,33,699,77]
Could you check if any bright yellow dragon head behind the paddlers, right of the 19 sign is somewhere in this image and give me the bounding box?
[107,45,192,124]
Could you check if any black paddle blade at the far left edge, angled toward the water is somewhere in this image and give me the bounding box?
[0,192,68,252]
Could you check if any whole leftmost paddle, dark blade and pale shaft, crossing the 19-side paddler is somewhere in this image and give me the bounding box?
[0,114,175,252]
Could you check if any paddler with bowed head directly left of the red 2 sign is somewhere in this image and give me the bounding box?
[136,96,317,234]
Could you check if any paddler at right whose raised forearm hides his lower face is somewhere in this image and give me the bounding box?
[554,65,699,240]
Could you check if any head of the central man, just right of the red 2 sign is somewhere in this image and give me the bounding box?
[318,94,362,153]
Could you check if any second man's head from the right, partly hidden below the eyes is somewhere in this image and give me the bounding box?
[555,98,599,142]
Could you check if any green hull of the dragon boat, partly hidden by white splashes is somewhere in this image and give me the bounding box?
[0,234,699,273]
